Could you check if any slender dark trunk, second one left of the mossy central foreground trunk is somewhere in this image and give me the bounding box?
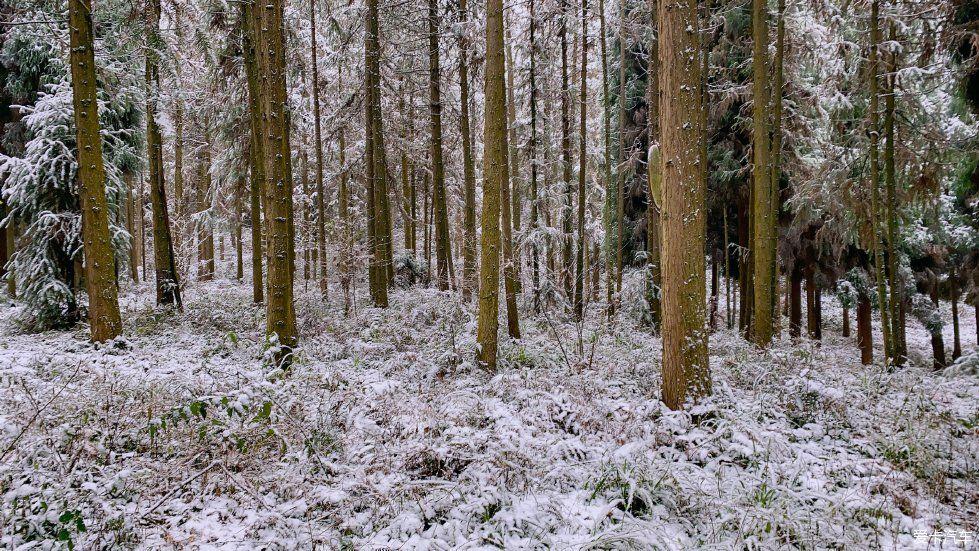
[428,0,454,291]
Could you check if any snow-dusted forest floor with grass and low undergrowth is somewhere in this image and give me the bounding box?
[0,262,979,549]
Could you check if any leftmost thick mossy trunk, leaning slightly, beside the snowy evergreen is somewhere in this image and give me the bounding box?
[68,0,122,342]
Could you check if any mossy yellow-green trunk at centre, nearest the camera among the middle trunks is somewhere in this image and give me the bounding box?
[476,0,508,369]
